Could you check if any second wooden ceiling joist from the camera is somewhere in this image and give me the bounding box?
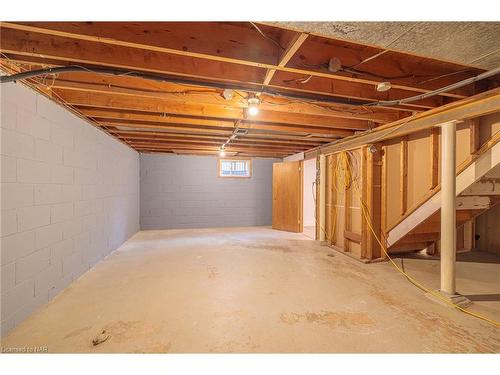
[0,24,464,108]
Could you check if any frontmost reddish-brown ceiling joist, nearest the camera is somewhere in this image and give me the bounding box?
[2,22,481,98]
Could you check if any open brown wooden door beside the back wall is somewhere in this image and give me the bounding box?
[273,161,302,232]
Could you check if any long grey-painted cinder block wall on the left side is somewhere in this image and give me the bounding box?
[0,83,139,335]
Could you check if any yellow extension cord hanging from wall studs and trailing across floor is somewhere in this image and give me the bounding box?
[321,151,500,327]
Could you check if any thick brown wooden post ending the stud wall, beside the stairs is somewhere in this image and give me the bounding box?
[361,144,383,260]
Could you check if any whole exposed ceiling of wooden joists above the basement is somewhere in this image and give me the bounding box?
[0,22,499,157]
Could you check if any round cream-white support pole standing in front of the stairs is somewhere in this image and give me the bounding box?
[441,121,457,295]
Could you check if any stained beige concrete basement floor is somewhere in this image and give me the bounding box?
[2,227,500,353]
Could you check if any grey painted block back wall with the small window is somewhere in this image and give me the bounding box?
[140,154,281,229]
